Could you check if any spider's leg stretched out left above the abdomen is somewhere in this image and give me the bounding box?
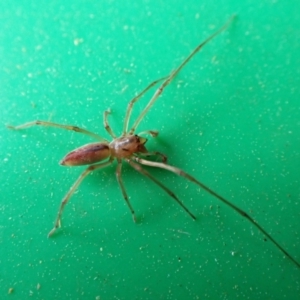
[7,120,106,141]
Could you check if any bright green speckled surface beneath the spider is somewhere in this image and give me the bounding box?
[0,0,300,300]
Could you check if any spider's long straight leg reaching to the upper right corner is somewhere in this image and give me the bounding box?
[129,16,235,134]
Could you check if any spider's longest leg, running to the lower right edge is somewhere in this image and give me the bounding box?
[133,157,300,268]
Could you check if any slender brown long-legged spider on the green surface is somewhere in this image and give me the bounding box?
[7,16,300,268]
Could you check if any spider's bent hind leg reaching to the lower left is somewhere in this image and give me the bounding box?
[48,158,113,237]
